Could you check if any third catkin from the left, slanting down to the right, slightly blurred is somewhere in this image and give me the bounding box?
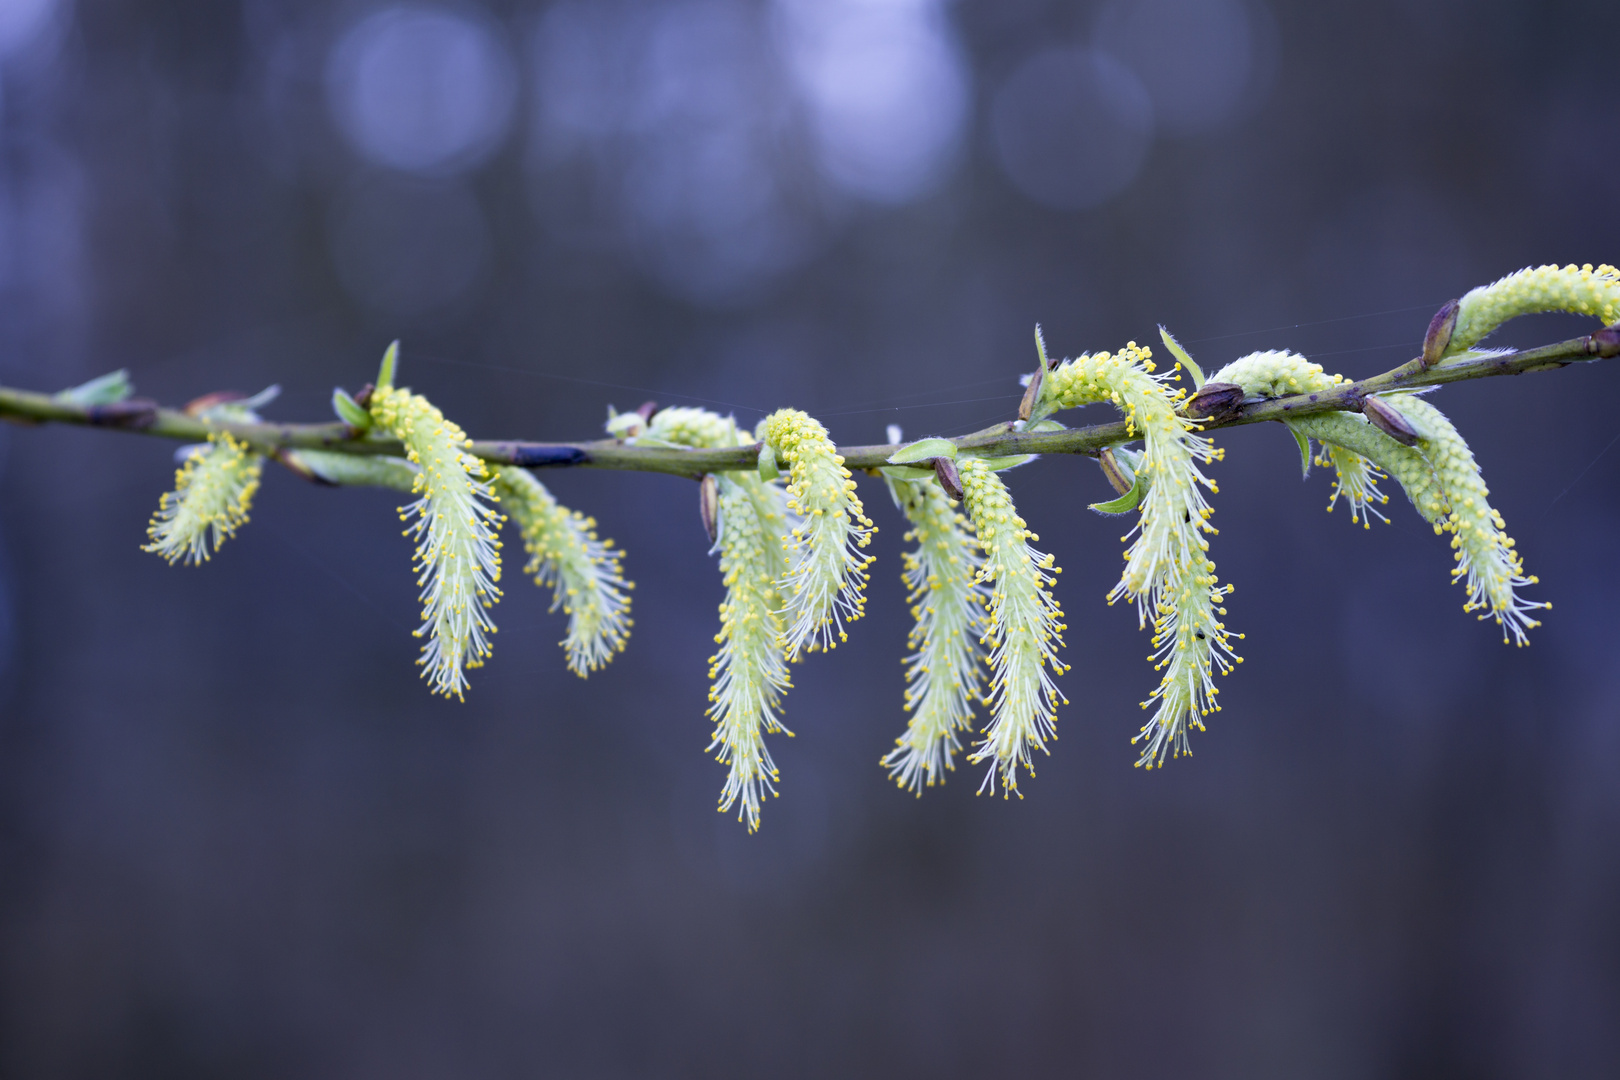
[494,465,635,678]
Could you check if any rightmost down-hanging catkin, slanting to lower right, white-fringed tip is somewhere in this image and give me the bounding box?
[1383,395,1547,644]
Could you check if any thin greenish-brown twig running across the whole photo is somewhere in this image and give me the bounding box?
[0,327,1620,478]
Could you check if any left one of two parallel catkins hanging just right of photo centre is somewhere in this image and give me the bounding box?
[881,479,990,795]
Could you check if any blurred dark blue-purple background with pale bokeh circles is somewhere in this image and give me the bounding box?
[0,0,1620,1078]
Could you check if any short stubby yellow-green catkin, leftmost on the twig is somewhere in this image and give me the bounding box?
[141,431,264,565]
